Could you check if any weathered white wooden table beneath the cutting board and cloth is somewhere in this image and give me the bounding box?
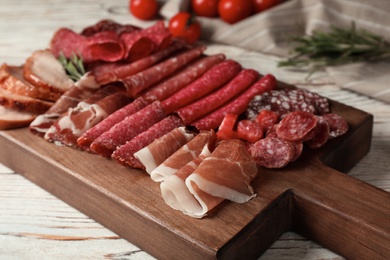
[0,0,390,259]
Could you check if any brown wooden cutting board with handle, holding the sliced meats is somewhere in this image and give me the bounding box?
[0,97,390,259]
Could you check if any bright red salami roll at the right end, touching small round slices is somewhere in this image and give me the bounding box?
[191,74,276,130]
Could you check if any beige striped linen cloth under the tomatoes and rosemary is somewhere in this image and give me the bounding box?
[161,0,390,103]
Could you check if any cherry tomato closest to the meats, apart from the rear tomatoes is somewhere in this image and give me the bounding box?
[168,12,201,44]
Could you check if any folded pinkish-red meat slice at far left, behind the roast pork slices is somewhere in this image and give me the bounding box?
[50,28,126,63]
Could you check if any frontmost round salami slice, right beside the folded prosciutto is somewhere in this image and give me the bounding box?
[249,137,295,169]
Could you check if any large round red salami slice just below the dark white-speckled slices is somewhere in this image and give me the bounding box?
[276,111,318,142]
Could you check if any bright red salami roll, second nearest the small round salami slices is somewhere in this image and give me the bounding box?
[176,69,259,124]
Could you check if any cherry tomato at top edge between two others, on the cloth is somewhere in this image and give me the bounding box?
[218,0,252,24]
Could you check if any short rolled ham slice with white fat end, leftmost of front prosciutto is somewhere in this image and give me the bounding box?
[134,127,195,174]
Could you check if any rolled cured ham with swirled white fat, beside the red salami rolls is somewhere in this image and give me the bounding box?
[44,86,130,147]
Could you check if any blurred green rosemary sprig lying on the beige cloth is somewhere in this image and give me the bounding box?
[278,23,390,75]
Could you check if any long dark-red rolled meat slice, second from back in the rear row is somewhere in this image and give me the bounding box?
[121,46,206,97]
